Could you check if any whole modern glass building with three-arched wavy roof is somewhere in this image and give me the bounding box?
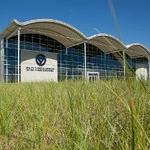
[0,19,150,82]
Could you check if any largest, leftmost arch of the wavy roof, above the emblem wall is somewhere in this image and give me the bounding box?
[3,19,86,47]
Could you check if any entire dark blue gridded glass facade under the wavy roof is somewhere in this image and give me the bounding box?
[1,34,148,82]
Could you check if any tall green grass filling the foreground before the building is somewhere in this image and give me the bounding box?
[0,80,150,150]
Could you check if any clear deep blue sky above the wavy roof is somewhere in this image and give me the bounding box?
[0,0,150,48]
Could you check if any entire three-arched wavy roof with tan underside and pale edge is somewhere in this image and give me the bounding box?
[0,19,150,57]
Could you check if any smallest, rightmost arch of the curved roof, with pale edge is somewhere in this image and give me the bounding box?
[126,43,150,58]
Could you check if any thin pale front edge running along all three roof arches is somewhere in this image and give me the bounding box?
[0,18,150,54]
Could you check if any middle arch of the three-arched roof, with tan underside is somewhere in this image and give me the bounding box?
[88,33,126,53]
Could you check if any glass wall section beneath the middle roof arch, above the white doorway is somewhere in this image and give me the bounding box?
[87,44,123,78]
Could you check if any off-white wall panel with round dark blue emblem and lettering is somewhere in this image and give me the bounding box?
[21,50,58,82]
